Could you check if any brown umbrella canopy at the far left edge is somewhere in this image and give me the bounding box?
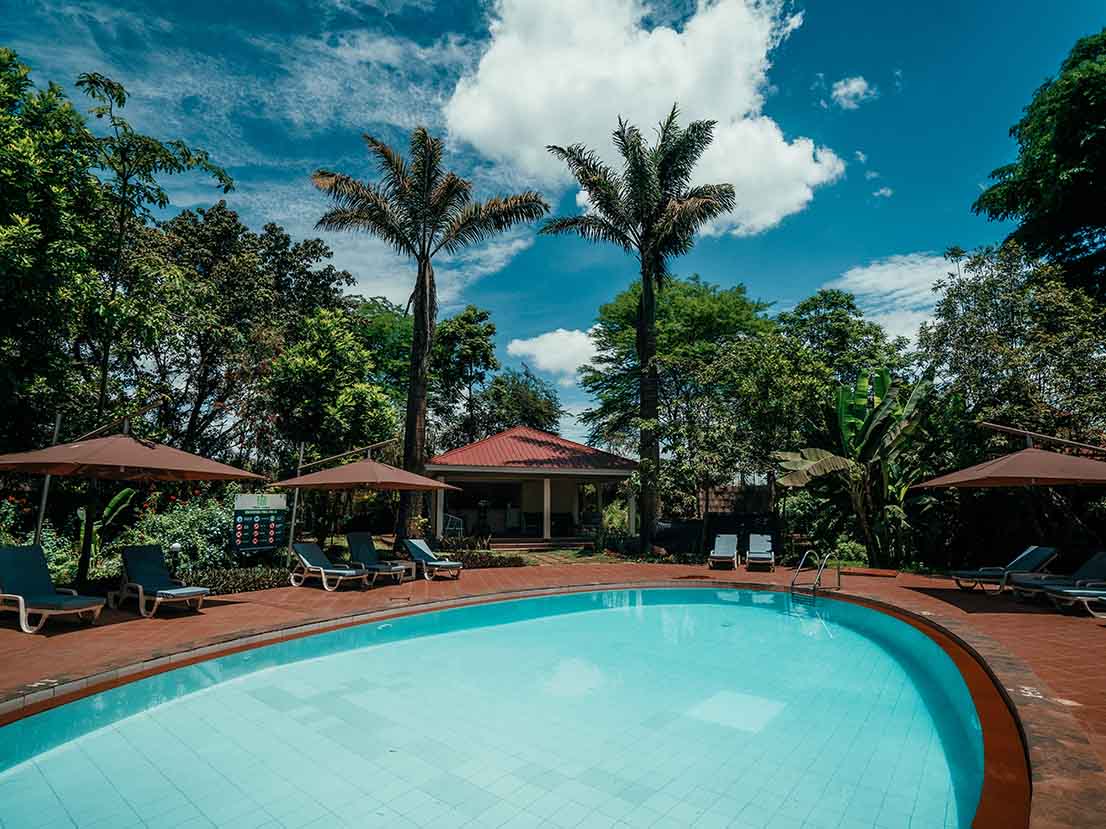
[0,434,264,481]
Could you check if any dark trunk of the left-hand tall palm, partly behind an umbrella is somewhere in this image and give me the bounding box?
[397,259,438,546]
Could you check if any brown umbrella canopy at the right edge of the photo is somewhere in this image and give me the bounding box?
[915,449,1106,489]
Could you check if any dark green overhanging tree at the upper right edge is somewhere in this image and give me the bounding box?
[972,29,1106,297]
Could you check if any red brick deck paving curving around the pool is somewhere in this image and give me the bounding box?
[0,564,1106,829]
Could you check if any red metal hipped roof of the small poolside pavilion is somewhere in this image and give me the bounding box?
[429,426,637,472]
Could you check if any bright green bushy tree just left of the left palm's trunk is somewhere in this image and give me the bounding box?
[268,308,397,458]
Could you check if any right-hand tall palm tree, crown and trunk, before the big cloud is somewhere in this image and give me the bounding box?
[541,105,735,553]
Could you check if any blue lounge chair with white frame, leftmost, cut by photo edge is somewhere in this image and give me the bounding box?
[0,544,105,633]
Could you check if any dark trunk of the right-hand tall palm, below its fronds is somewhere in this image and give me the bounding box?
[637,269,660,555]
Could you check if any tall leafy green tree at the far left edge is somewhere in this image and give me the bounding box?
[0,49,103,451]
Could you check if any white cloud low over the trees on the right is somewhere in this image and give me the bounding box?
[823,252,948,338]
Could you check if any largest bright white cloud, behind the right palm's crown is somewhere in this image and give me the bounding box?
[445,0,845,234]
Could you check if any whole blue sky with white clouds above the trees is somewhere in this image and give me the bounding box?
[0,0,1106,442]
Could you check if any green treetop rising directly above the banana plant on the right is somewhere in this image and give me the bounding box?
[776,288,909,384]
